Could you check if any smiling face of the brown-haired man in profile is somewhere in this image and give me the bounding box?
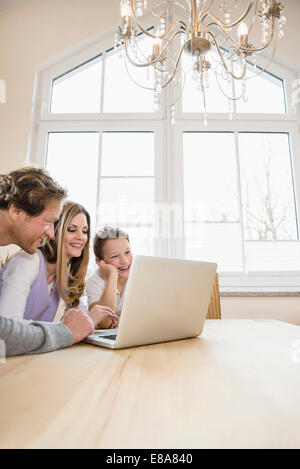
[9,199,62,254]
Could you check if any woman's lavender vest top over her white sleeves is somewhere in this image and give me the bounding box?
[0,249,60,322]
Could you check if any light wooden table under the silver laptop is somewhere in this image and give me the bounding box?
[0,319,300,449]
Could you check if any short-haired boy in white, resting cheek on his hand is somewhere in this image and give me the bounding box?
[86,226,133,328]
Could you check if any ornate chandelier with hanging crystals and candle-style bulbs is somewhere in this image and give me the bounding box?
[115,0,286,121]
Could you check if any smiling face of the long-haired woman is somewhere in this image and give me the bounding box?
[65,213,89,259]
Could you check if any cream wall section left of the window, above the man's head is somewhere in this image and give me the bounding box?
[0,0,120,172]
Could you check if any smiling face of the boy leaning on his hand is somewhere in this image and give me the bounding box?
[102,238,133,279]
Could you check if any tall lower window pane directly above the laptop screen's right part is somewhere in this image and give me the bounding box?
[183,132,243,272]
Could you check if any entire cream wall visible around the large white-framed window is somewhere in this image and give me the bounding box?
[0,0,300,325]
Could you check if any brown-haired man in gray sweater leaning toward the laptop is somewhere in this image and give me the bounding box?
[0,167,113,355]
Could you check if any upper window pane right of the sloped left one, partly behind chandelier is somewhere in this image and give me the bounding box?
[103,38,153,112]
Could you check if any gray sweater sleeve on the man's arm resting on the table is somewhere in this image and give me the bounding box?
[0,316,74,356]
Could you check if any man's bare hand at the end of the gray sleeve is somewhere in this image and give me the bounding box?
[62,308,95,344]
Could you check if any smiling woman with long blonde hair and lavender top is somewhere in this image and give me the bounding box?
[0,202,118,323]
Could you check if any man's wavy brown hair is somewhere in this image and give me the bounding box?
[0,166,67,216]
